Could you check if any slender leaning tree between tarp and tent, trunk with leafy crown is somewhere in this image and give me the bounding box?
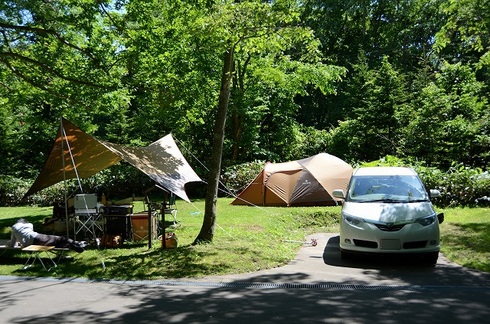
[188,0,341,243]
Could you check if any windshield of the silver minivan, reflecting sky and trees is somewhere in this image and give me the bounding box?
[347,175,428,202]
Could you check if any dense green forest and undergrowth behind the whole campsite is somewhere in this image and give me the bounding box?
[0,0,490,206]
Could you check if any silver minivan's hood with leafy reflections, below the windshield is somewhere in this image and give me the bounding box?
[342,201,435,223]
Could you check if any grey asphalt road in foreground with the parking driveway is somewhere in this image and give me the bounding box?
[0,234,490,323]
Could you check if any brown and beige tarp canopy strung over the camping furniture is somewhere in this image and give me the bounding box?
[25,119,201,201]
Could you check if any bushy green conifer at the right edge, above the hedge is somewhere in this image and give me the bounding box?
[401,64,489,168]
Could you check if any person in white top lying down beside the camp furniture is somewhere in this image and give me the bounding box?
[6,218,84,253]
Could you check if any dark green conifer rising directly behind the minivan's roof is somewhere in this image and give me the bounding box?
[333,56,406,160]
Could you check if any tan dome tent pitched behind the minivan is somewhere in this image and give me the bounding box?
[232,153,352,206]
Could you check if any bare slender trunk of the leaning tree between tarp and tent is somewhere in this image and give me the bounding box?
[193,47,234,244]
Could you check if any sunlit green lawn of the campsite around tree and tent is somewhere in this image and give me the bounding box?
[0,198,490,280]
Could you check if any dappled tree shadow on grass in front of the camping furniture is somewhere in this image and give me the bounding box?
[0,244,229,280]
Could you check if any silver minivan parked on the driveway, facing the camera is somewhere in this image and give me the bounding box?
[333,167,444,264]
